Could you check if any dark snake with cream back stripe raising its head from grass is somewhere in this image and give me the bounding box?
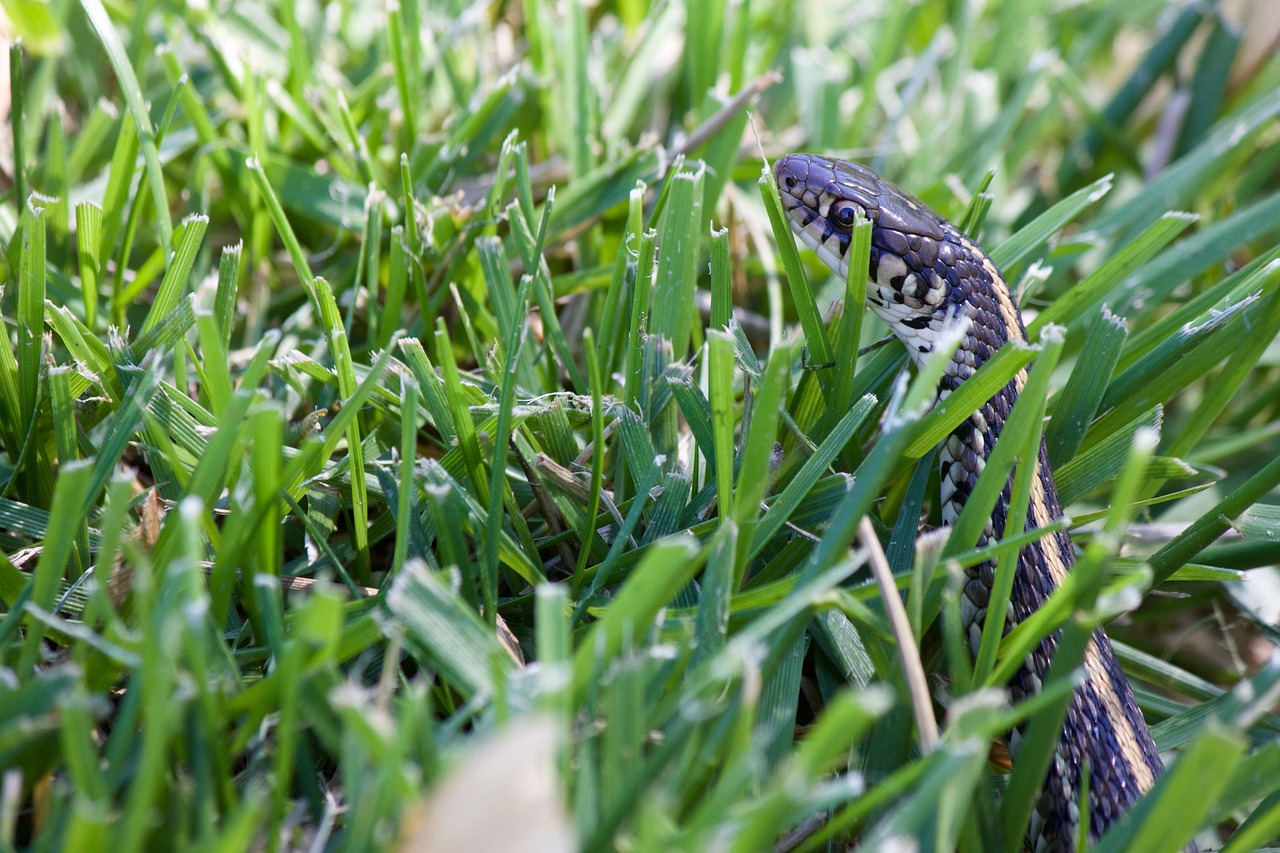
[773,154,1177,853]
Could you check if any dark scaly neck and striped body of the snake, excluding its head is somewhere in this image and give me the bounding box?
[868,213,1162,852]
